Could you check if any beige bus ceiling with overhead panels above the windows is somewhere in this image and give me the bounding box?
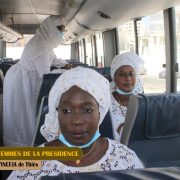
[0,0,180,44]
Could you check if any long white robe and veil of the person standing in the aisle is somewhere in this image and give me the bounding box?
[3,16,66,146]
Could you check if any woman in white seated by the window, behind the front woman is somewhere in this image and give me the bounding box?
[110,52,144,142]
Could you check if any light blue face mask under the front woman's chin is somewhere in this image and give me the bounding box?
[59,131,101,149]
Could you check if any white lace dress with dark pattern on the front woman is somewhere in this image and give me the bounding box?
[8,139,143,180]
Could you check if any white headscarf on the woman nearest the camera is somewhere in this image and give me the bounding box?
[41,67,110,141]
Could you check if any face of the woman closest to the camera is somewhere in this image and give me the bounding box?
[58,86,100,145]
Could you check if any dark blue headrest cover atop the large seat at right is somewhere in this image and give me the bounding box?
[143,94,180,138]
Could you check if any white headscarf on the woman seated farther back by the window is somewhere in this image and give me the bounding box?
[110,52,144,94]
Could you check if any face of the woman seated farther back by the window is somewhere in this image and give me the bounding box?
[114,65,136,92]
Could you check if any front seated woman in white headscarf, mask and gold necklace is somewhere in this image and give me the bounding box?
[9,67,143,179]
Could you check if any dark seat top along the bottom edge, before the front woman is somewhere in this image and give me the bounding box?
[41,167,180,180]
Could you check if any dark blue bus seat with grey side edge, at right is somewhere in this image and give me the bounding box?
[121,93,180,167]
